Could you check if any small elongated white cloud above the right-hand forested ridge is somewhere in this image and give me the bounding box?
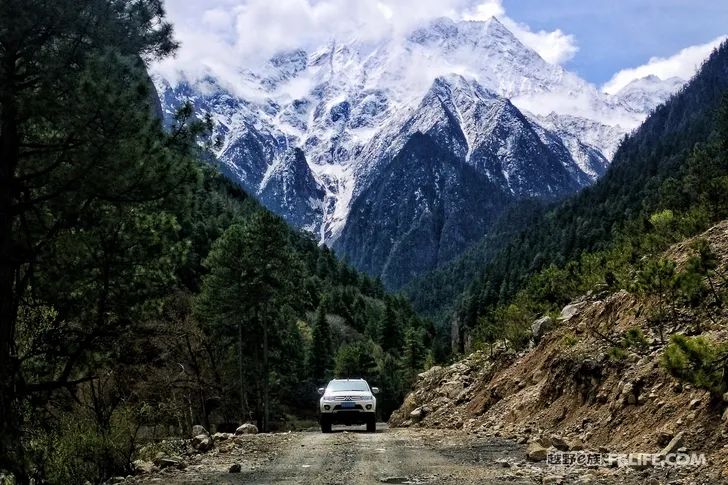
[602,36,728,94]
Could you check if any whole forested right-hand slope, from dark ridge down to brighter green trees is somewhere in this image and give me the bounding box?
[404,44,728,349]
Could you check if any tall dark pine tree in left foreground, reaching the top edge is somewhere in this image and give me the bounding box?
[0,0,182,481]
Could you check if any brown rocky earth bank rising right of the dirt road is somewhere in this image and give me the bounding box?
[390,221,728,479]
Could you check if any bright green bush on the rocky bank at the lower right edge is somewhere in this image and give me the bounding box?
[662,334,728,396]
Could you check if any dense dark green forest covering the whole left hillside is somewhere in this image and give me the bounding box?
[0,0,436,483]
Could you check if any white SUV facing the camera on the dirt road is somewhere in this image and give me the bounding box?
[318,379,379,433]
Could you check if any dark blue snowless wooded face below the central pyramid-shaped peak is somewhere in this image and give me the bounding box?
[337,133,510,288]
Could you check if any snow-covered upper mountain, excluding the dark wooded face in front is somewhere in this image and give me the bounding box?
[155,17,680,246]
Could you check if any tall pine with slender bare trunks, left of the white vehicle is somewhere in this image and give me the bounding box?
[197,211,302,430]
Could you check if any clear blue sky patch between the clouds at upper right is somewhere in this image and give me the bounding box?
[503,0,728,85]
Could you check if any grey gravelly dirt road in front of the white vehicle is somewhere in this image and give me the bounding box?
[125,425,704,485]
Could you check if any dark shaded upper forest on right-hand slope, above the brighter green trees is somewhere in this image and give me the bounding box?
[406,39,728,327]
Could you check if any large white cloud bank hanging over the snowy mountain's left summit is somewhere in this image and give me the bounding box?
[157,0,577,83]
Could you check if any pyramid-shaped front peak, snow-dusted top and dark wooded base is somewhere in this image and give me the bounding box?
[334,76,603,288]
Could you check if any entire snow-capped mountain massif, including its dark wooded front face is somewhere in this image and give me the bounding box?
[155,18,679,284]
